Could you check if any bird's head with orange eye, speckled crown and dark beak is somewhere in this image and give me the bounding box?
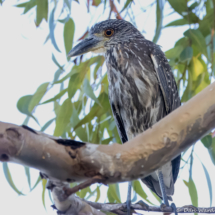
[68,19,143,57]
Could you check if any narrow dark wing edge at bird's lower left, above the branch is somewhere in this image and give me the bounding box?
[111,103,128,143]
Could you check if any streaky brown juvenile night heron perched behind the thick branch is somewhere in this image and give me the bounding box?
[69,19,181,214]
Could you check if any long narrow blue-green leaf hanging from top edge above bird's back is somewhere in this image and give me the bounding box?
[153,0,164,43]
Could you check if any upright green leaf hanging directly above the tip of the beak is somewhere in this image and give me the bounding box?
[63,18,75,59]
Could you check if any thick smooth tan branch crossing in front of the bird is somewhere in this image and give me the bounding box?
[0,83,215,183]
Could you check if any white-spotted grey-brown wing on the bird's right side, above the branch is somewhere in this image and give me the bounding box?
[151,46,181,114]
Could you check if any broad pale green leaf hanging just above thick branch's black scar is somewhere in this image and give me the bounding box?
[54,98,73,137]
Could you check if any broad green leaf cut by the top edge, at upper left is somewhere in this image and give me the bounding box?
[36,0,48,26]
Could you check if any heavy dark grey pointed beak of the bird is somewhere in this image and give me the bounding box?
[68,37,103,57]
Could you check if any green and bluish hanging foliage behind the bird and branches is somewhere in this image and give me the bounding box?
[0,0,215,212]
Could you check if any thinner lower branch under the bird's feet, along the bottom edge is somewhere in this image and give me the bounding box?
[49,181,215,215]
